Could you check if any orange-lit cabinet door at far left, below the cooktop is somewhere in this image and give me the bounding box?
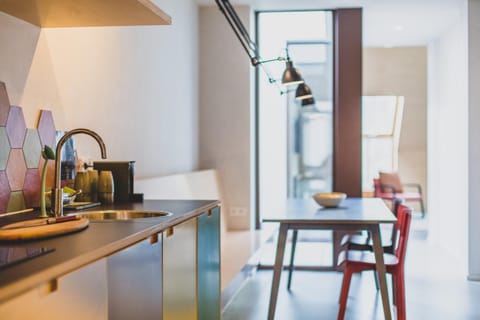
[0,259,107,320]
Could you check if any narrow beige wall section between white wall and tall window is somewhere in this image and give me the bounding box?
[199,6,253,229]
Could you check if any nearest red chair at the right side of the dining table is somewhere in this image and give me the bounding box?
[338,205,412,320]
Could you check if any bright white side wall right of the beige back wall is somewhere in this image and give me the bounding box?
[427,0,468,273]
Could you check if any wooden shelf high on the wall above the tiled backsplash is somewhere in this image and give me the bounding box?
[0,0,172,28]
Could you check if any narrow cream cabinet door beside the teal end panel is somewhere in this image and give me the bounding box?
[163,219,197,320]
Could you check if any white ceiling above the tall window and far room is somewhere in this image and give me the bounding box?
[196,0,465,47]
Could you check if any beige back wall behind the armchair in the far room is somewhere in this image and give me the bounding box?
[363,47,427,210]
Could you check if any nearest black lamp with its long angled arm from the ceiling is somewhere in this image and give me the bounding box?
[215,0,303,86]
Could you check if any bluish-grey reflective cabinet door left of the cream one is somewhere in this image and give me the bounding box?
[107,235,162,320]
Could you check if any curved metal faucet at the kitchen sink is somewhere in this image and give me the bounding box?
[52,128,107,217]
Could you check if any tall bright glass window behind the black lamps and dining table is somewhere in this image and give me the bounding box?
[256,10,333,225]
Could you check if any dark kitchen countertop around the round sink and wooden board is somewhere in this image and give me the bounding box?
[0,200,220,303]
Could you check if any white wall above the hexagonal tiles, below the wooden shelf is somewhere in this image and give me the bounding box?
[0,0,198,177]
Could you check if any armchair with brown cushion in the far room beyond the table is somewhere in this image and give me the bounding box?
[373,172,425,218]
